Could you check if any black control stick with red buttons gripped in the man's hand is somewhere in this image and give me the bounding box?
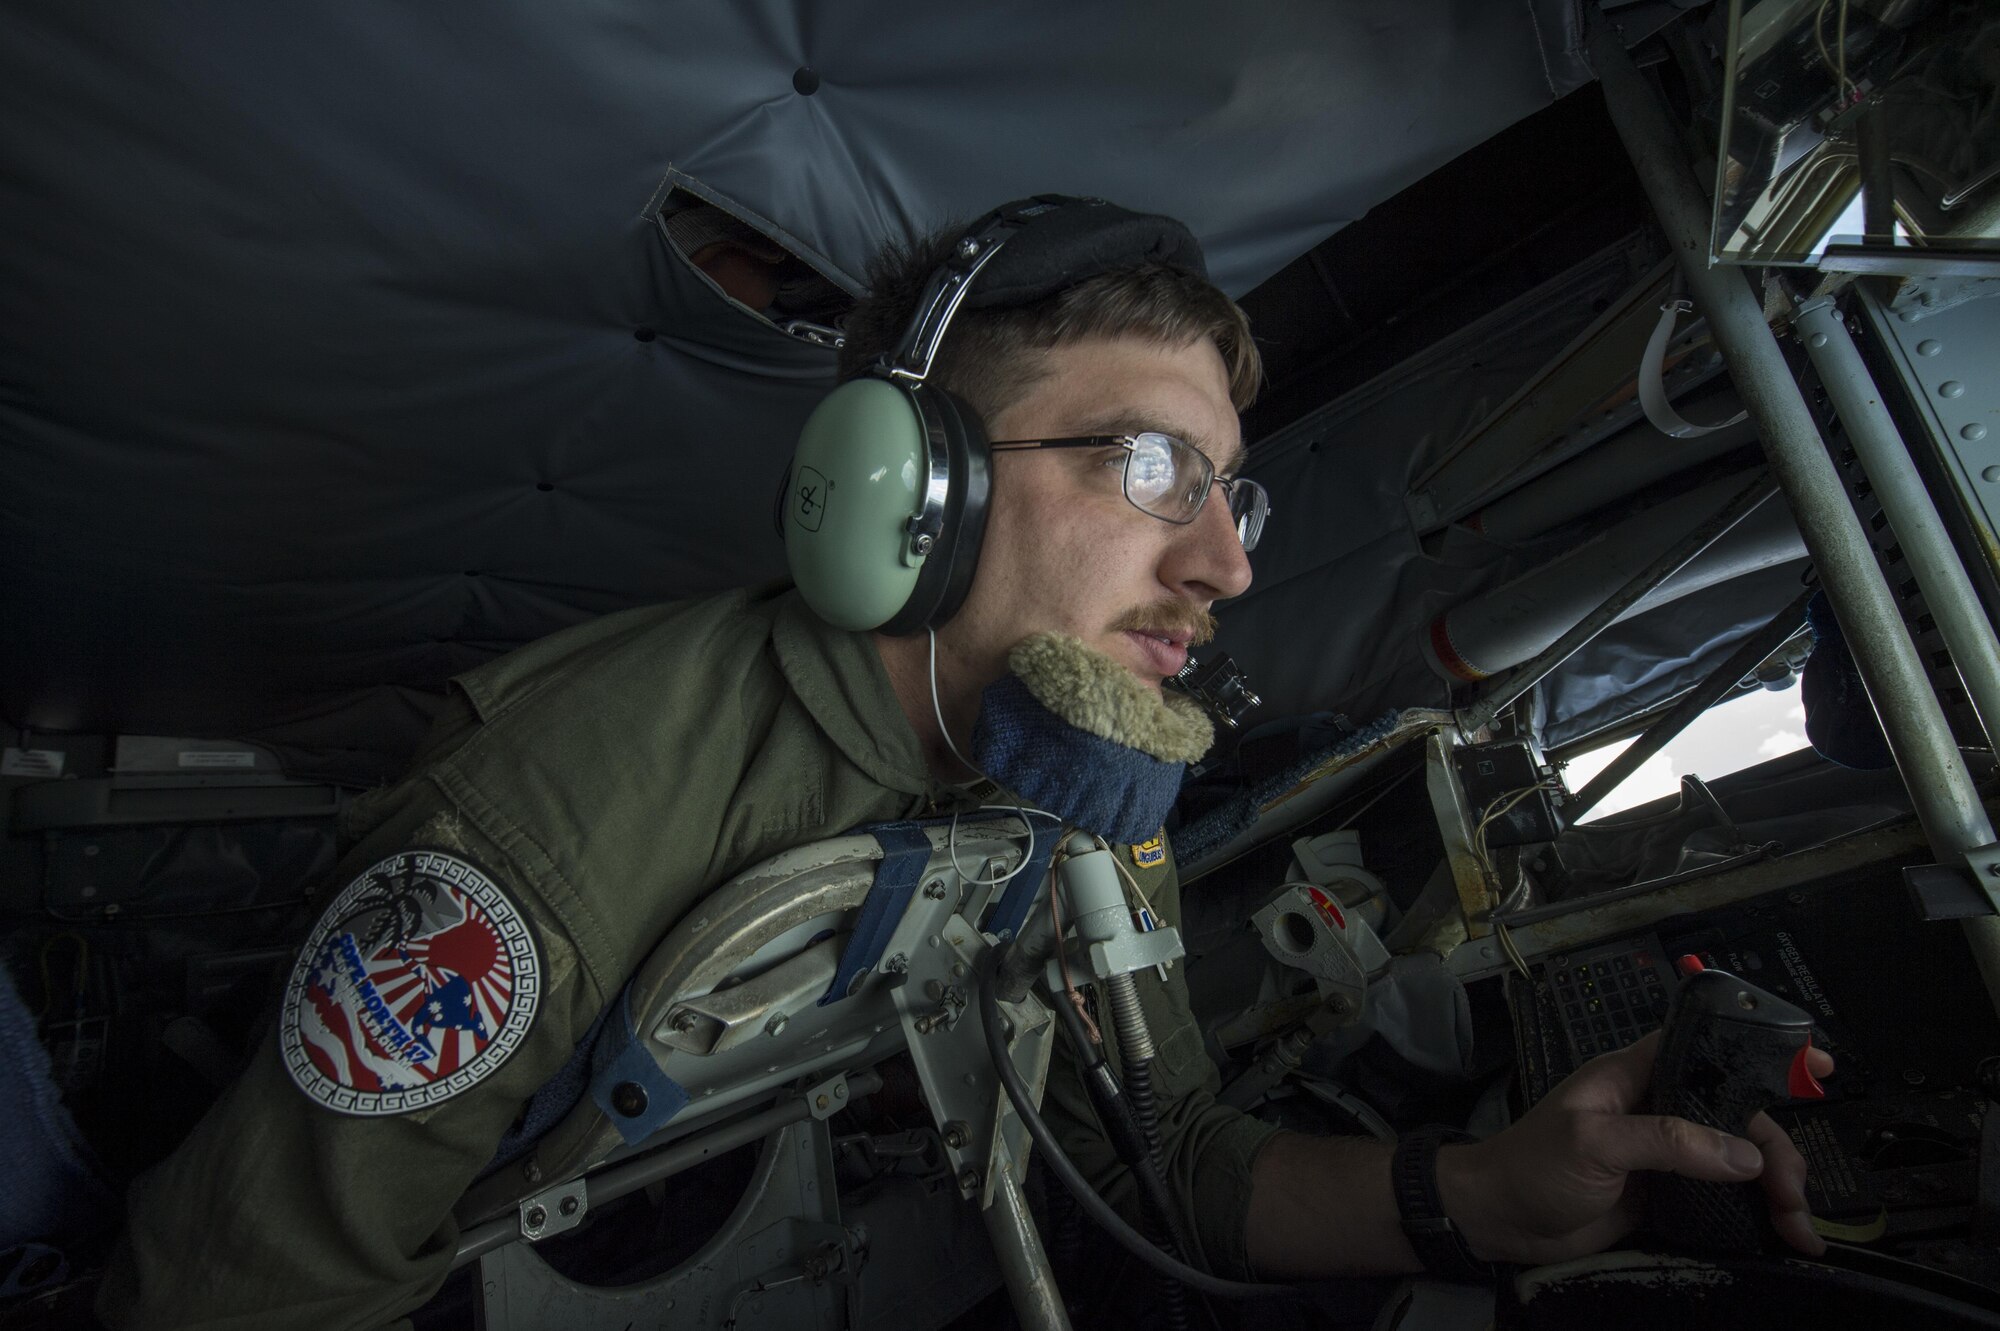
[1646,957,1826,1253]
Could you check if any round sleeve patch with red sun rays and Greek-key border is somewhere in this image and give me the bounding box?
[278,849,542,1117]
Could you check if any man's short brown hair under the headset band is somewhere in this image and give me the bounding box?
[840,226,1264,420]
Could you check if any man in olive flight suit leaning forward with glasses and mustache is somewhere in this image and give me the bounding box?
[100,199,1816,1329]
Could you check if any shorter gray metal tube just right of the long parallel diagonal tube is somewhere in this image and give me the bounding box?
[1796,298,2000,739]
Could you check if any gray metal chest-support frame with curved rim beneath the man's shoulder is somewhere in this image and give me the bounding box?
[458,815,1080,1331]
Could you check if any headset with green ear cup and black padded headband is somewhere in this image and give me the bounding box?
[778,194,1208,636]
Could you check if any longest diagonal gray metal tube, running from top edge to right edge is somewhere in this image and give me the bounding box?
[1586,14,2000,983]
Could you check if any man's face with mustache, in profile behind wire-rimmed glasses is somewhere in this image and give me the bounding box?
[938,329,1250,687]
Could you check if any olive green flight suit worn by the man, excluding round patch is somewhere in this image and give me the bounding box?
[98,592,1270,1331]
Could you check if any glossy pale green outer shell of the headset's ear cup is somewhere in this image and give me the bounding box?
[784,378,930,630]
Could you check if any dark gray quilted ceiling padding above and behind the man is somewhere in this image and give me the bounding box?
[0,0,1552,775]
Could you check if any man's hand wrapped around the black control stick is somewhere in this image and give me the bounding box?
[1438,1033,1834,1265]
